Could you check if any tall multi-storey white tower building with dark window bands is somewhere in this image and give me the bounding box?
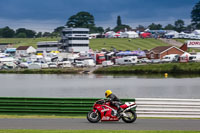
[61,28,89,53]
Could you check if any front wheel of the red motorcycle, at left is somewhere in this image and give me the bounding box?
[87,111,101,123]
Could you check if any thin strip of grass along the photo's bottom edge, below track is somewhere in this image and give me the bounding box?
[0,129,200,133]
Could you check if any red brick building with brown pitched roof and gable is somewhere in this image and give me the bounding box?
[146,46,185,59]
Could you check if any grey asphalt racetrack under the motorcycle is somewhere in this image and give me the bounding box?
[0,118,200,131]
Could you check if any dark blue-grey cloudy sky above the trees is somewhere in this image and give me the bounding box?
[0,0,199,32]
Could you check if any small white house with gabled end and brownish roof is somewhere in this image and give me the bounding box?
[16,46,36,56]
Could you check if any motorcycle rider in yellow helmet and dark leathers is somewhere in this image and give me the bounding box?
[105,90,123,114]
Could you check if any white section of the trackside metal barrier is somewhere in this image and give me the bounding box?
[136,98,200,118]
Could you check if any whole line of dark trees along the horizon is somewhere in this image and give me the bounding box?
[0,1,200,38]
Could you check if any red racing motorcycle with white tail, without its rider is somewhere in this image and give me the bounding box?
[87,99,137,123]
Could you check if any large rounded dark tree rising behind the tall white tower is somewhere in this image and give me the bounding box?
[66,12,95,28]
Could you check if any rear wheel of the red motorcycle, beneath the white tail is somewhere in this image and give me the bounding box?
[122,110,137,123]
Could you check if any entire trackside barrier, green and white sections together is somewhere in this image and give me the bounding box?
[0,97,200,118]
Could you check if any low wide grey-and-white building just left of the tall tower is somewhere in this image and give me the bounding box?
[37,41,62,53]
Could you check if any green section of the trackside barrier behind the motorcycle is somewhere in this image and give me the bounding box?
[0,97,135,115]
